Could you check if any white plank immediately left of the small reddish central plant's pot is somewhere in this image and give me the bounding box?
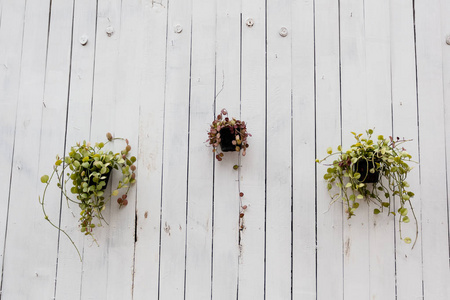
[184,0,216,300]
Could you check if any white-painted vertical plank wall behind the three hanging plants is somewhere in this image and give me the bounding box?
[0,0,450,300]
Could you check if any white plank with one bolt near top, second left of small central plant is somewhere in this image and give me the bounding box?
[159,0,192,299]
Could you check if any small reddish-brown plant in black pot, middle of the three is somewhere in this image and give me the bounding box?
[207,108,251,161]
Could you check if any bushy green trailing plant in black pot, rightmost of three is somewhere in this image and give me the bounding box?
[316,129,418,248]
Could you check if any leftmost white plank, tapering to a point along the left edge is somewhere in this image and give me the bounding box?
[0,1,25,290]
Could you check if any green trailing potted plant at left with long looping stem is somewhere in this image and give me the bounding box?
[39,133,136,259]
